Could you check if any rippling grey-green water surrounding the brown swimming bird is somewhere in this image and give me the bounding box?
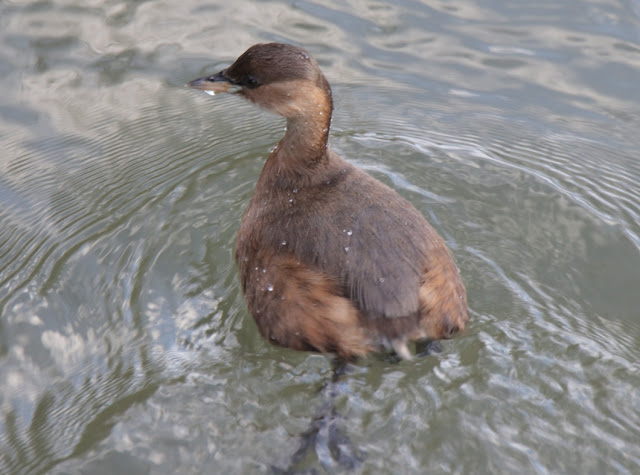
[0,1,640,473]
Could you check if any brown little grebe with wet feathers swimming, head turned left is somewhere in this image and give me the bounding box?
[188,43,469,360]
